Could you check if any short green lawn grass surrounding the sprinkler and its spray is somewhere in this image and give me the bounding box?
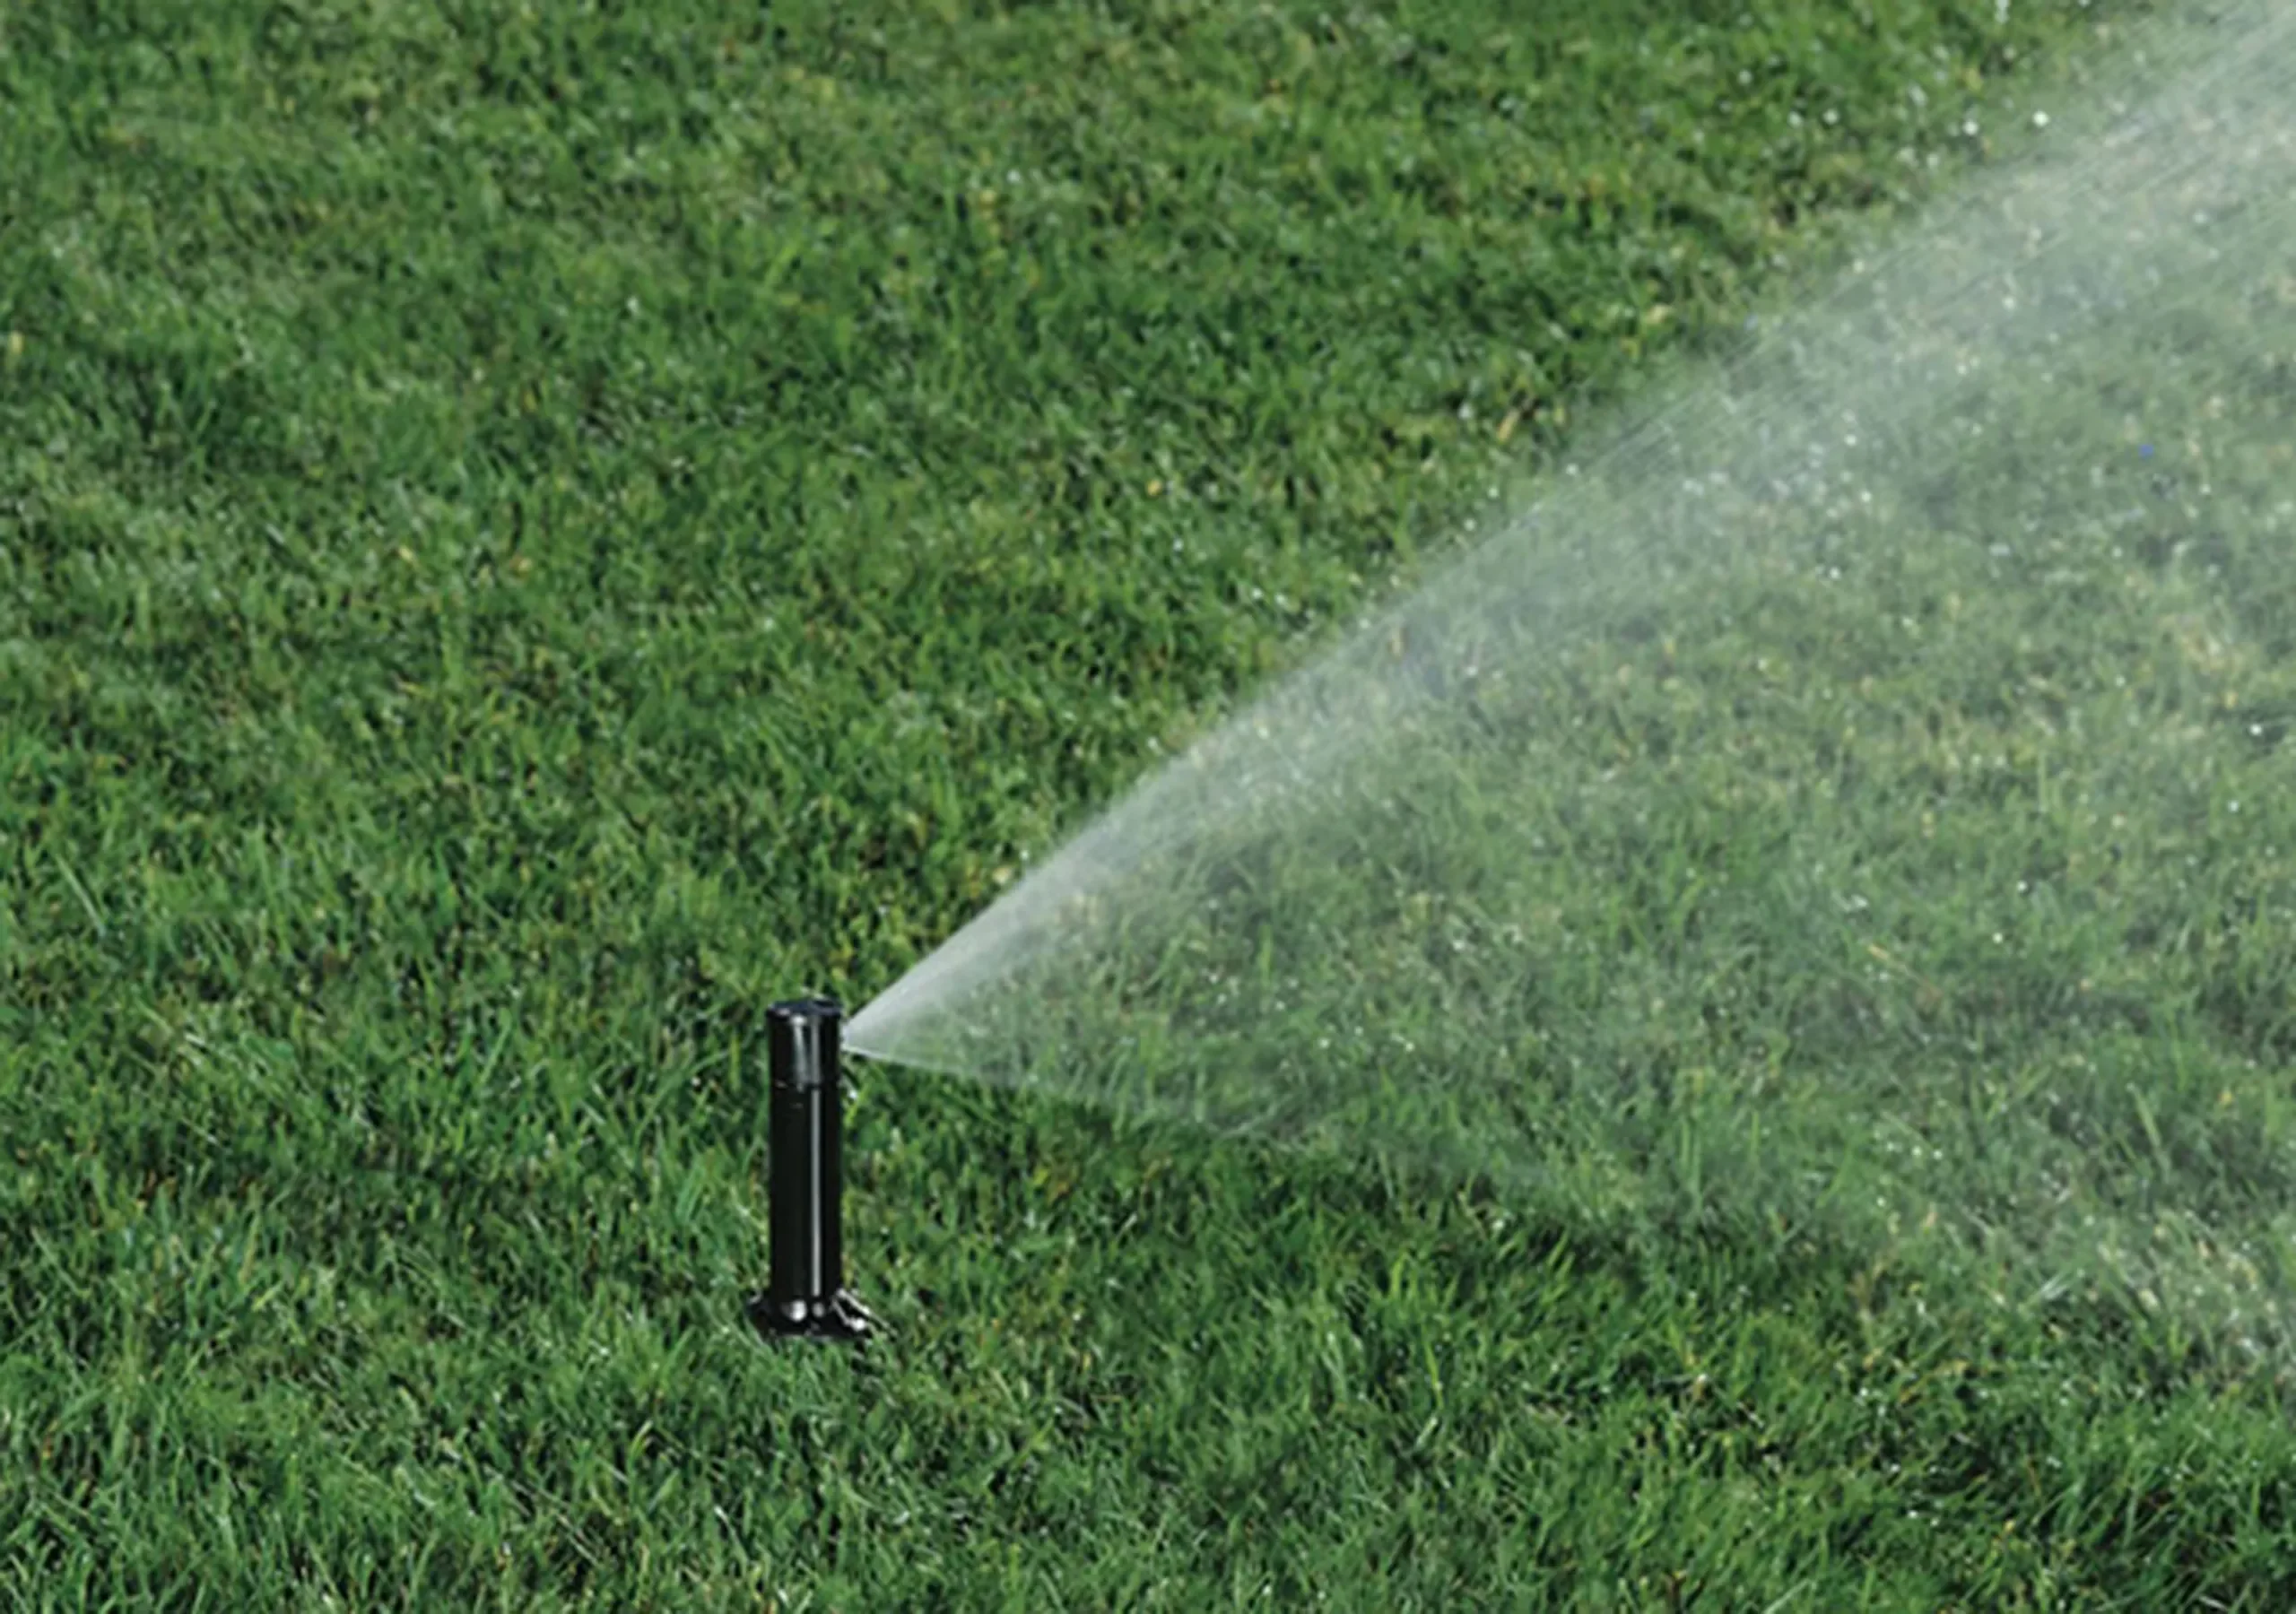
[0,0,2296,1610]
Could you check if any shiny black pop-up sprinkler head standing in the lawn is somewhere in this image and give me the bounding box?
[749,999,874,1341]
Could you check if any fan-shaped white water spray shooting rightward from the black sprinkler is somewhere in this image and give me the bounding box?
[848,4,2296,1341]
